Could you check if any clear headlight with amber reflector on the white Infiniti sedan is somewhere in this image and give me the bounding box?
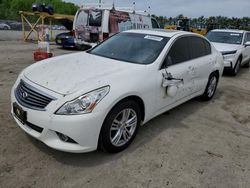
[56,86,110,115]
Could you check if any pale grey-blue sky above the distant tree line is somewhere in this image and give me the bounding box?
[64,0,250,18]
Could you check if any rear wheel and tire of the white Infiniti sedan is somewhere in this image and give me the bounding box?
[201,73,219,101]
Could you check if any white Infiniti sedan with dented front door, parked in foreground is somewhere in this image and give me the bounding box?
[11,30,223,152]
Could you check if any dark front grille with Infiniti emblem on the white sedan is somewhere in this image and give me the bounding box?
[15,80,55,110]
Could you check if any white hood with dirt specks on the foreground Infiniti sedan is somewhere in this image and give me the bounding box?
[23,52,141,95]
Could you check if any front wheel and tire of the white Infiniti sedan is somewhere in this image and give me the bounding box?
[99,100,141,153]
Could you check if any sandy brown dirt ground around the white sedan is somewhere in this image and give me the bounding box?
[0,32,250,188]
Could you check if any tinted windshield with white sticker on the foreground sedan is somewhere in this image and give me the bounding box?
[89,33,169,64]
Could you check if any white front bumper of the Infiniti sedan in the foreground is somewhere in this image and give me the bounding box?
[11,80,106,153]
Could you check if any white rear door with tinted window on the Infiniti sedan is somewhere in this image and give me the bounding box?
[189,36,216,92]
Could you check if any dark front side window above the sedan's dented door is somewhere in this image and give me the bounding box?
[164,37,191,67]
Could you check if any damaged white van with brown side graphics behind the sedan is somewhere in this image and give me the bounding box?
[73,7,159,47]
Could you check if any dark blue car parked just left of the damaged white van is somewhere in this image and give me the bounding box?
[56,31,77,48]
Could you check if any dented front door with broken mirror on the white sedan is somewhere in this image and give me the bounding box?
[157,36,196,110]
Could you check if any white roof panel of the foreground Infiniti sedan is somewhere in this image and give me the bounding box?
[124,29,192,38]
